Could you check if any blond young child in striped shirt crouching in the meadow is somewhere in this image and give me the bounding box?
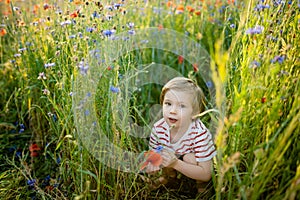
[146,77,216,192]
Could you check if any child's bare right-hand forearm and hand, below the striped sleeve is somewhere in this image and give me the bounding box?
[162,151,212,182]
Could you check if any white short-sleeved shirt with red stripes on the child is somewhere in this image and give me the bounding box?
[149,118,216,162]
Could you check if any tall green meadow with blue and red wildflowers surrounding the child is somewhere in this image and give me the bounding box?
[0,0,300,199]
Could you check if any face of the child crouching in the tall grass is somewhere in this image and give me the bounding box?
[163,90,193,131]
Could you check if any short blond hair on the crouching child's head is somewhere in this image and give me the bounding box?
[160,77,204,115]
